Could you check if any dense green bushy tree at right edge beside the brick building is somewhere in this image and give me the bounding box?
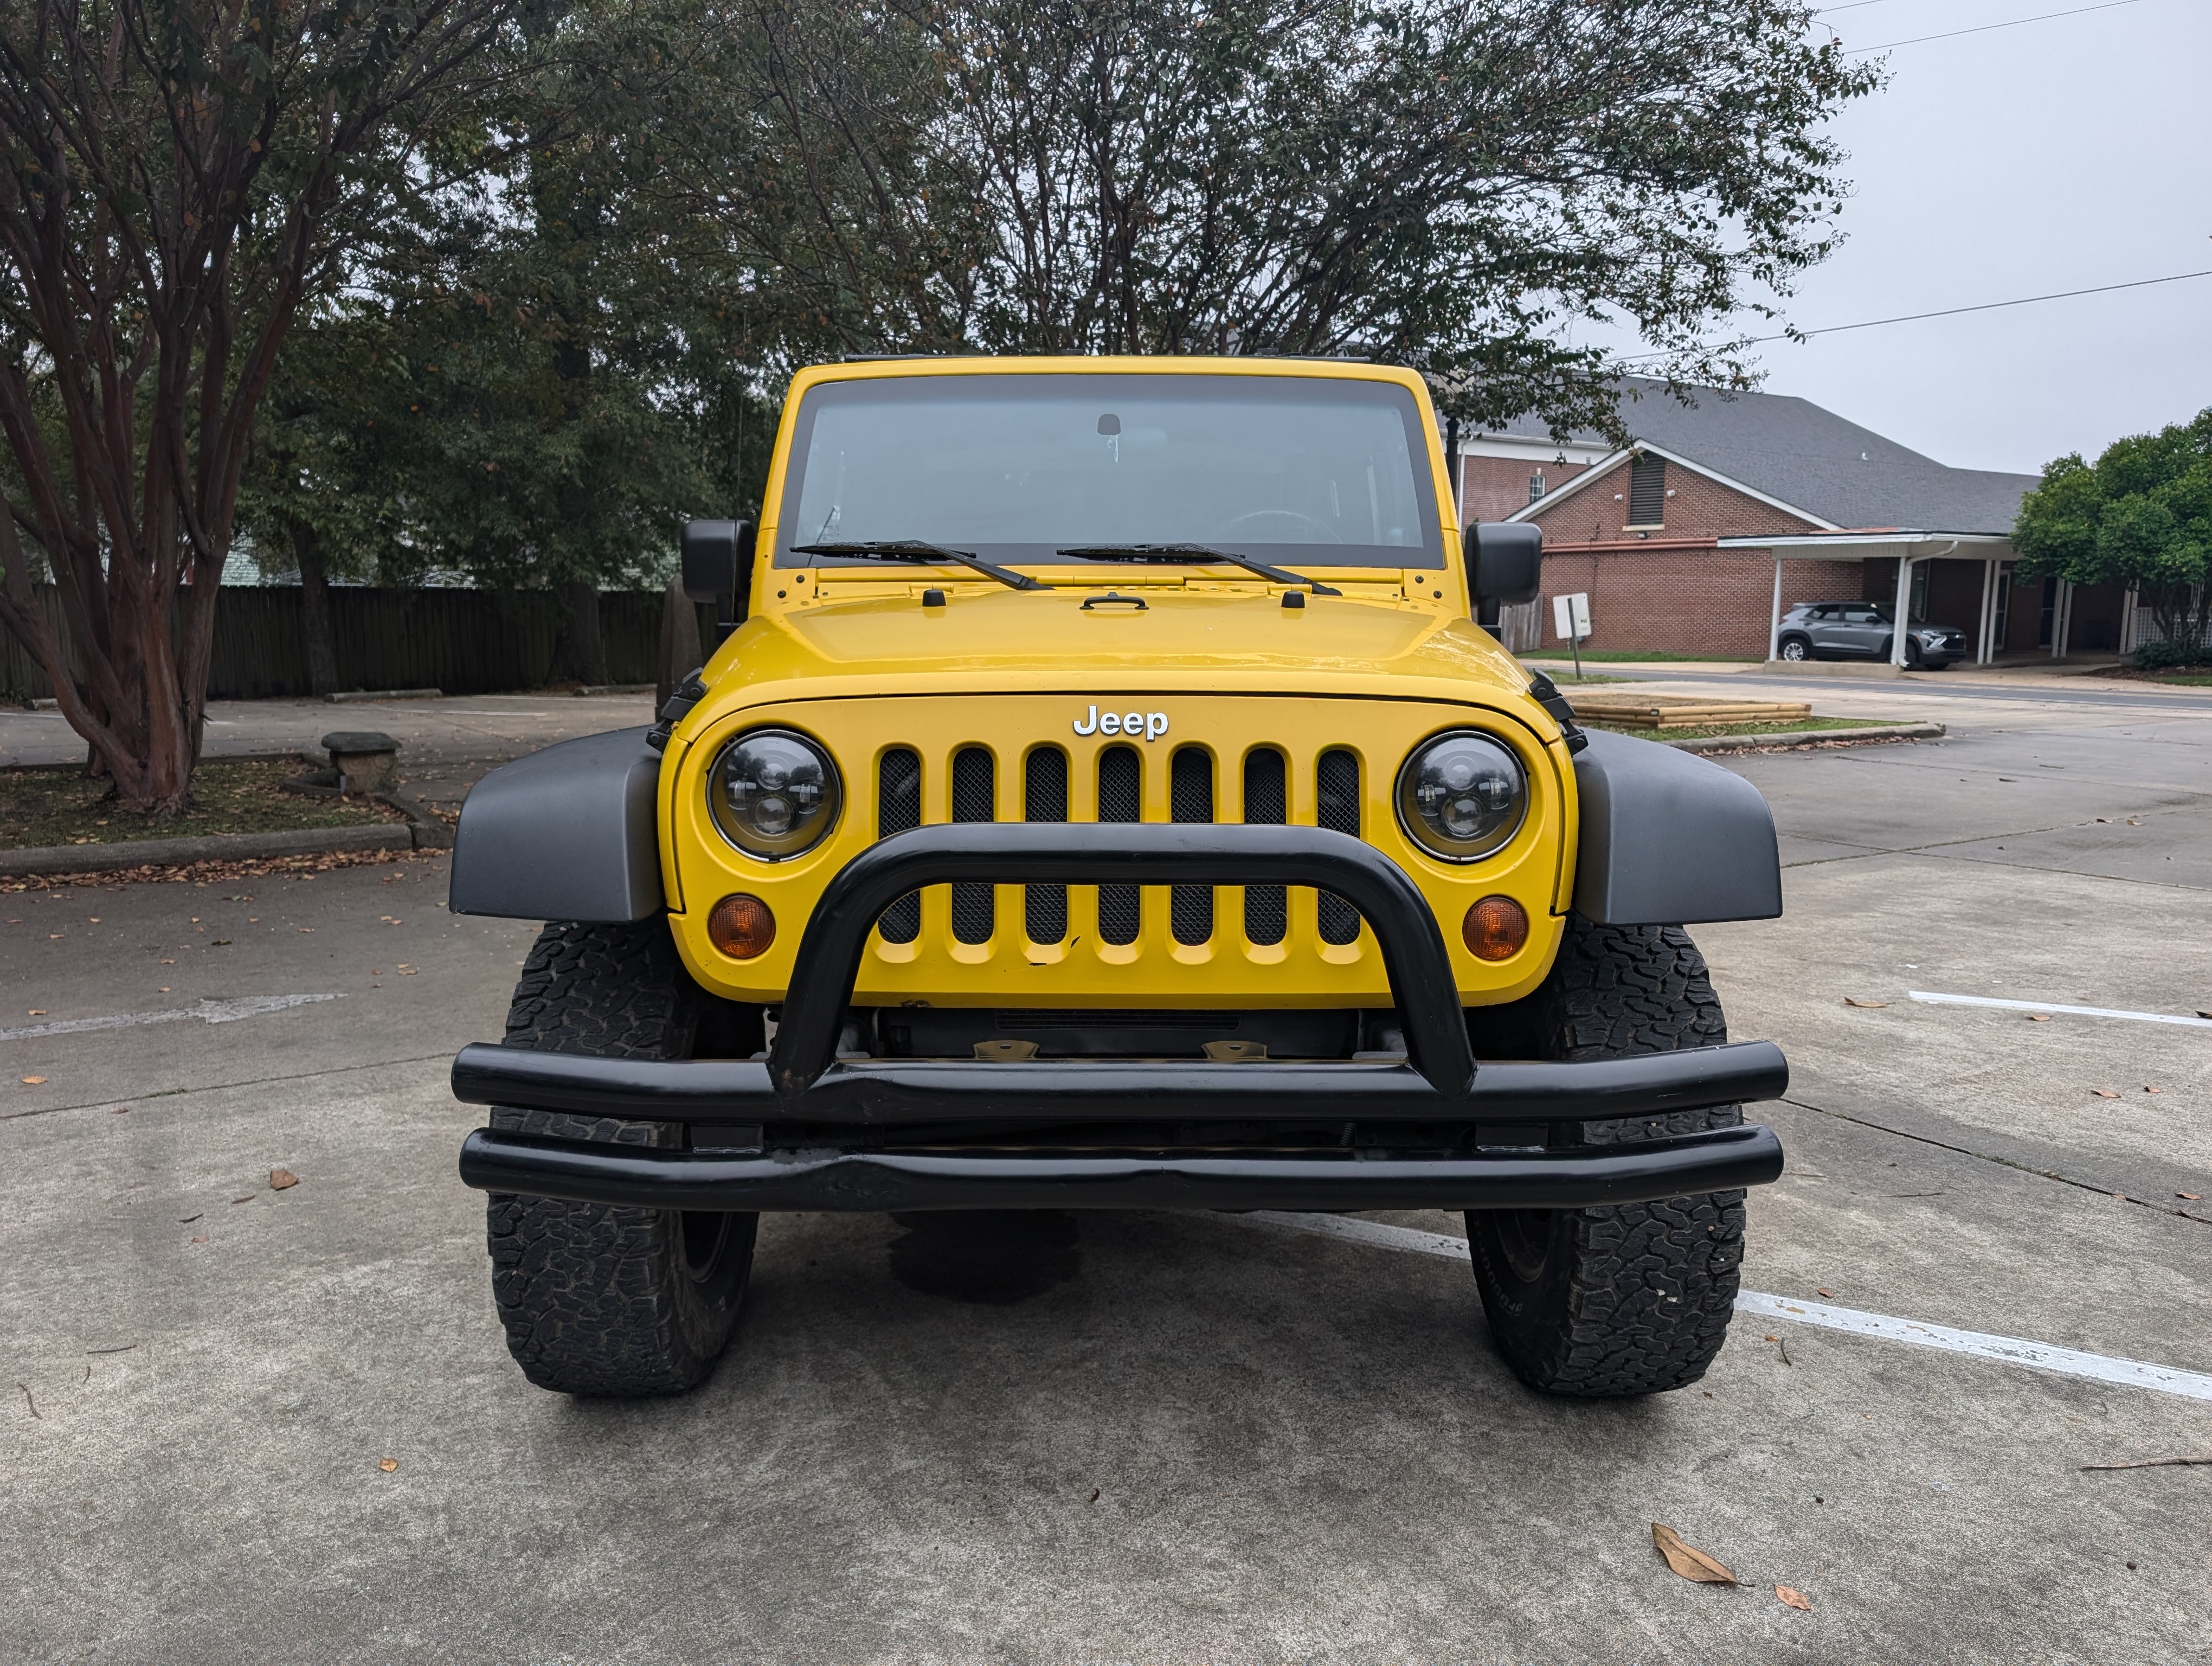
[2013,409,2212,662]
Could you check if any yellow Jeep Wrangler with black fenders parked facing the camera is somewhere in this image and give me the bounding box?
[451,358,1787,1396]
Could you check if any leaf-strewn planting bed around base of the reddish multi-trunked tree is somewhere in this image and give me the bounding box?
[0,761,403,850]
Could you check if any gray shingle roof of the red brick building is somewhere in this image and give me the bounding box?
[1506,379,2040,533]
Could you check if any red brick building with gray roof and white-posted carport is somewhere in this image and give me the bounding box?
[1460,381,2148,664]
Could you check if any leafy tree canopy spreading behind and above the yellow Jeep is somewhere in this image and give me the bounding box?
[256,0,1878,584]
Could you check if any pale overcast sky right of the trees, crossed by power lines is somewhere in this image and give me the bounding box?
[1619,0,2212,473]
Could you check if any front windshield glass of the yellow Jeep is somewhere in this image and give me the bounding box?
[776,374,1444,566]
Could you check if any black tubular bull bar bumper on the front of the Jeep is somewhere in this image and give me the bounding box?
[453,823,1790,1210]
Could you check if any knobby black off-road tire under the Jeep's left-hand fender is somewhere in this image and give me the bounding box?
[489,918,761,1398]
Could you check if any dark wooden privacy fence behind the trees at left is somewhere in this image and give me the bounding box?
[0,584,661,706]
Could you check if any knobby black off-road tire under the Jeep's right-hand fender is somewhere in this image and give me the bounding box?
[1467,914,1743,1398]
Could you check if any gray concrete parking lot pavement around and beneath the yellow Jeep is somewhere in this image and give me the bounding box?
[0,688,2212,1666]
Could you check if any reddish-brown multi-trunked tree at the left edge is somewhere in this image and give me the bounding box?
[0,0,509,814]
